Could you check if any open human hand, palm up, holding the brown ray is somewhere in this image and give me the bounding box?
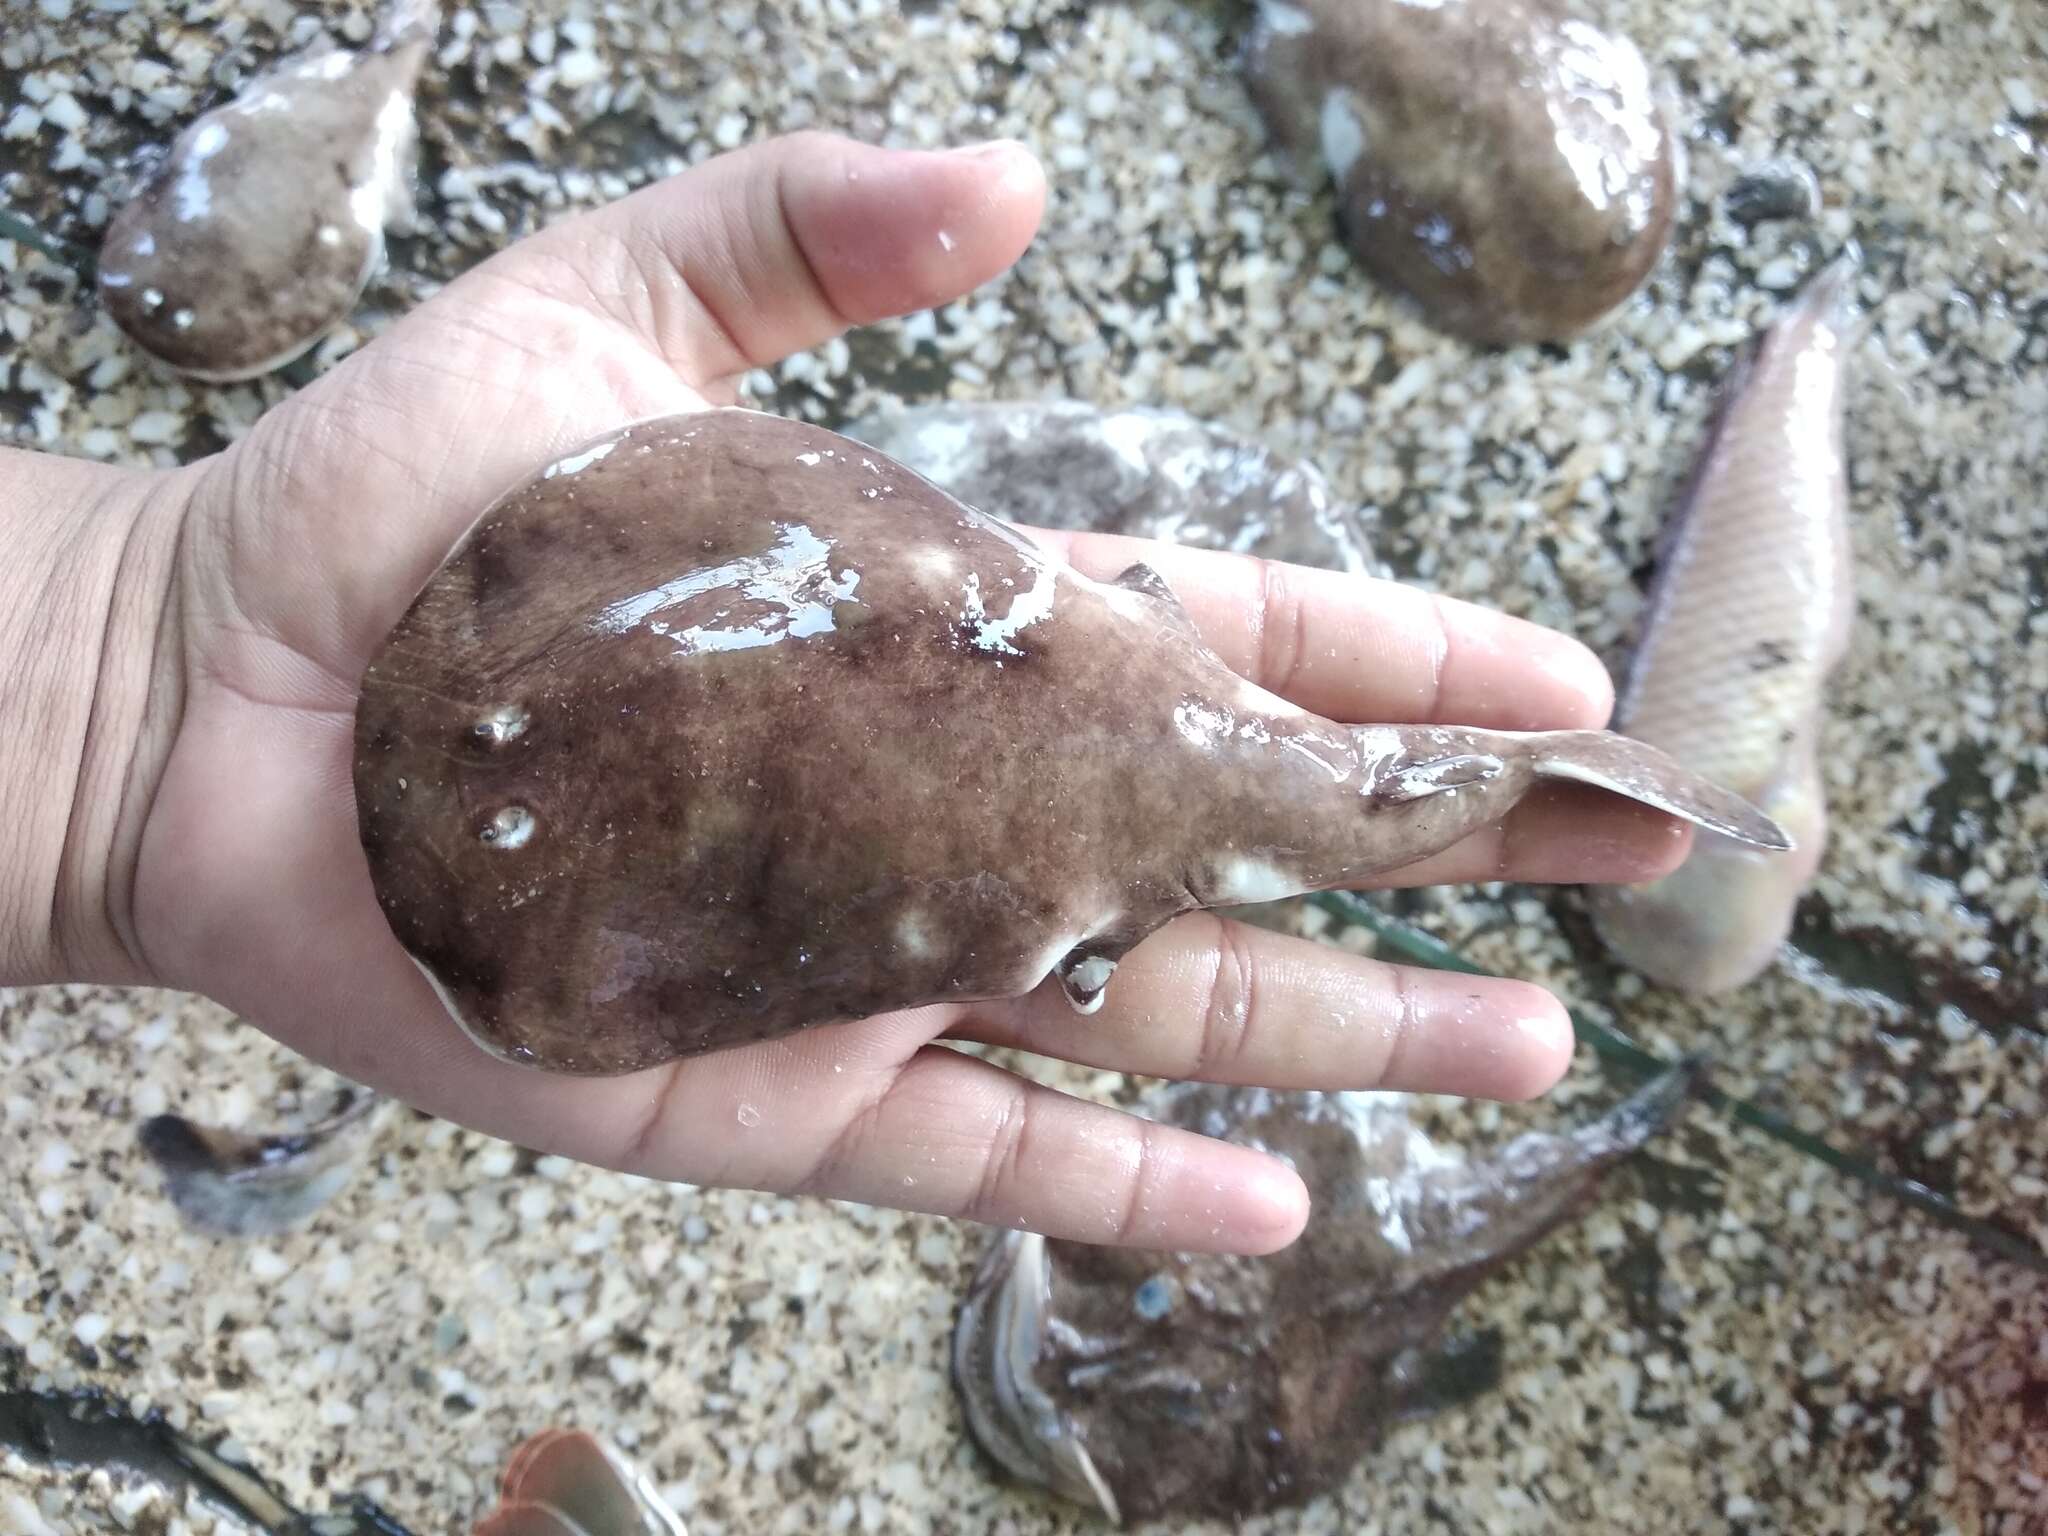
[16,135,1688,1251]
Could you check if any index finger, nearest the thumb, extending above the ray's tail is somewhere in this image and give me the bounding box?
[1026,528,1614,731]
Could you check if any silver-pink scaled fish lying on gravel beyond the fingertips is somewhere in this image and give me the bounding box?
[1589,256,1858,993]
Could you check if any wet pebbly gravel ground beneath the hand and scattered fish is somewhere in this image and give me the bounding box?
[0,0,2048,1536]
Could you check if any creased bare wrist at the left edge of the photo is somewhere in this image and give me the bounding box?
[0,451,186,985]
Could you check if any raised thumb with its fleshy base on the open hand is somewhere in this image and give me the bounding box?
[207,133,1044,680]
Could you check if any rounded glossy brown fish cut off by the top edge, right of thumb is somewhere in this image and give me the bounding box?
[1245,0,1677,344]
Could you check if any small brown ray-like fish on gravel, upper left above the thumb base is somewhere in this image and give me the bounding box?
[98,0,432,379]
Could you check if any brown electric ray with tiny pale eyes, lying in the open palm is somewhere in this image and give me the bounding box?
[354,410,1780,1073]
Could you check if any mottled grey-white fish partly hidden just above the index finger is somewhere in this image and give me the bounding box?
[846,399,1372,571]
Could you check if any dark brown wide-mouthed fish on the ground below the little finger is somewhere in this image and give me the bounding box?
[954,1069,1690,1522]
